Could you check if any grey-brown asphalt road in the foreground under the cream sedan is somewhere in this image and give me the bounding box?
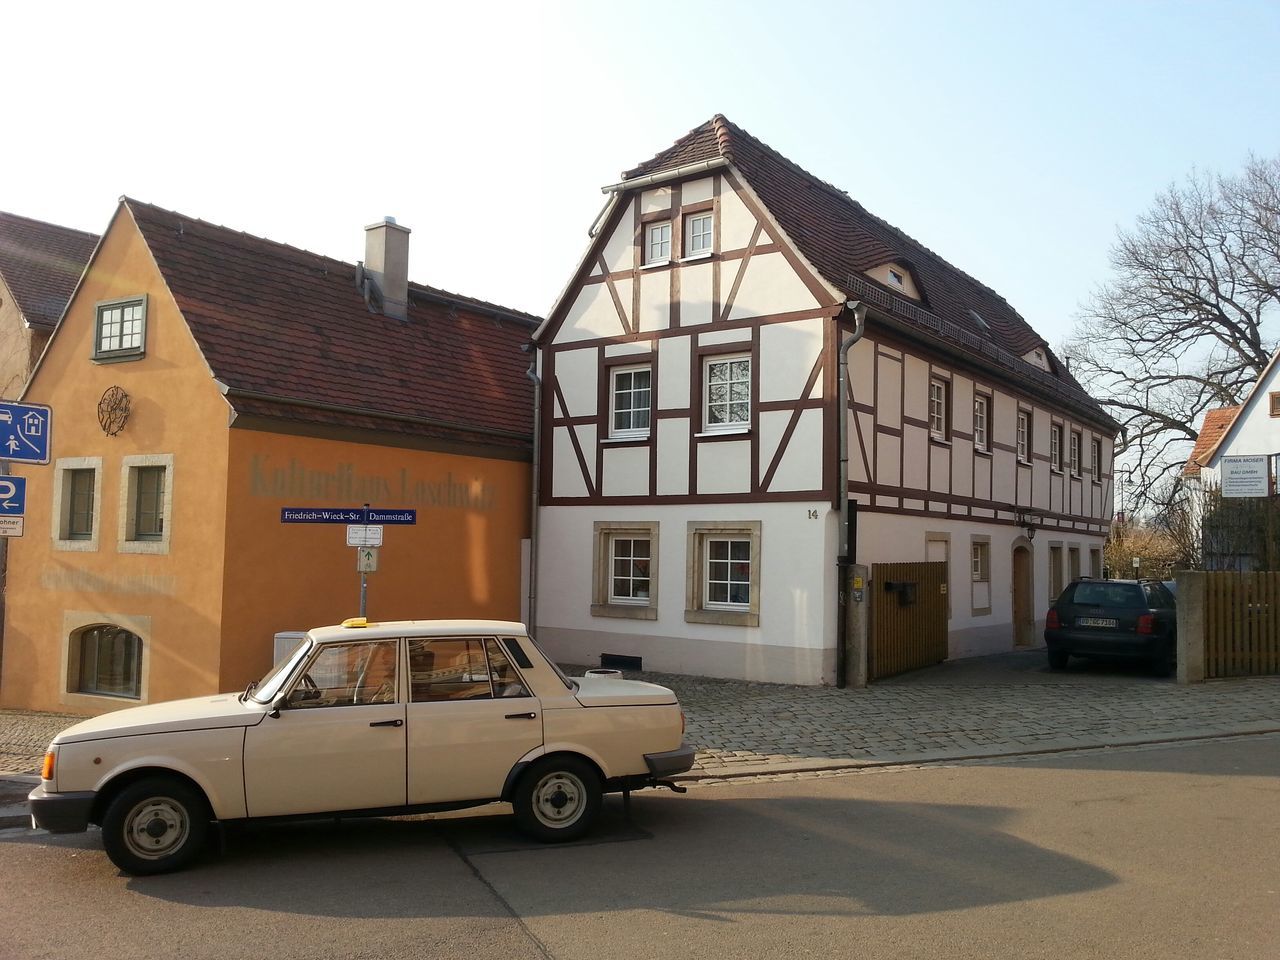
[0,735,1280,960]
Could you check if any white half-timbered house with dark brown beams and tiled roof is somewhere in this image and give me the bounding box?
[534,116,1116,684]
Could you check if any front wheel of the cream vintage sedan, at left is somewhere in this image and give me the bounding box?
[102,777,209,877]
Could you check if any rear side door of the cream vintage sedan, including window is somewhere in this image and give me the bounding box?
[406,636,543,804]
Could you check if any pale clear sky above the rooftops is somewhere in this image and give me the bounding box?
[0,0,1280,344]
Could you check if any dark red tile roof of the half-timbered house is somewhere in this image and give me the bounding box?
[622,114,1117,426]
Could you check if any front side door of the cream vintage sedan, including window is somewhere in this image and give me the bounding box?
[244,640,406,817]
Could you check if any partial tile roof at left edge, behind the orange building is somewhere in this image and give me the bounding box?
[0,212,97,328]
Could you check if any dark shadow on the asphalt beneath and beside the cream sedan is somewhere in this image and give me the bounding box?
[2,792,1116,919]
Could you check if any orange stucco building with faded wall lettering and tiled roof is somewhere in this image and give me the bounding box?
[0,198,536,713]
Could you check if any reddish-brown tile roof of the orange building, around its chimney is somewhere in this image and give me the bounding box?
[131,197,539,449]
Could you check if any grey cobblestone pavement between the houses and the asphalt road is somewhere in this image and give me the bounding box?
[0,650,1280,778]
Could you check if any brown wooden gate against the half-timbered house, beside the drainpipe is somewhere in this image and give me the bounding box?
[868,563,947,680]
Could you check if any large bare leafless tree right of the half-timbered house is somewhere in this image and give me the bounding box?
[1060,157,1280,519]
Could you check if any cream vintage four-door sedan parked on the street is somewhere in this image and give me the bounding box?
[29,618,694,874]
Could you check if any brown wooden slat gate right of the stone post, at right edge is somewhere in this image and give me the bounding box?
[1204,571,1280,677]
